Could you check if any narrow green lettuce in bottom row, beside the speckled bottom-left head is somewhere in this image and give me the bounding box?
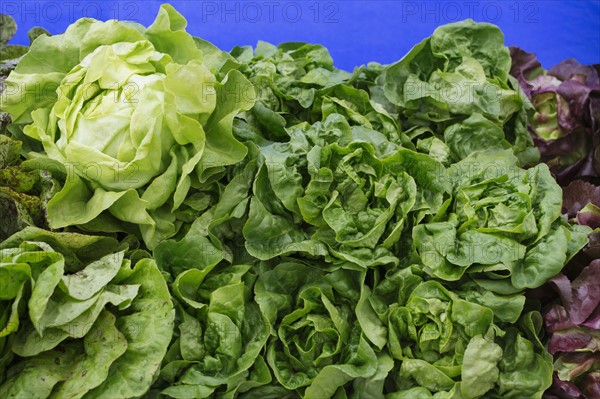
[155,236,271,398]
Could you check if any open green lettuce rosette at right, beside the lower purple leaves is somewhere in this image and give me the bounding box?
[412,150,590,293]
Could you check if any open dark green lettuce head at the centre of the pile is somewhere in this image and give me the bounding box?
[243,113,446,268]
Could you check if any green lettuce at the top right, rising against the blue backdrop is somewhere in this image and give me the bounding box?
[376,20,539,165]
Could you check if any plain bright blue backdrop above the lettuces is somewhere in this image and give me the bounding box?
[0,0,600,70]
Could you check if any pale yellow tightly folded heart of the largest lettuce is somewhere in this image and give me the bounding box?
[35,41,216,190]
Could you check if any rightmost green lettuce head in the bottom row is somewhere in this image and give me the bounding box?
[371,276,552,399]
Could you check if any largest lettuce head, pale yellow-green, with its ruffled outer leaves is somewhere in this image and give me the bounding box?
[2,5,254,247]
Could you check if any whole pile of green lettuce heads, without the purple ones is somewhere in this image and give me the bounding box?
[0,5,591,399]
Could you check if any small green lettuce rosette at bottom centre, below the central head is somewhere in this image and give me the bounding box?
[254,262,380,398]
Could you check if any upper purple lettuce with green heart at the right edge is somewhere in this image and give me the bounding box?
[510,47,600,186]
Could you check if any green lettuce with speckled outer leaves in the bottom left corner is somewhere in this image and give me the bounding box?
[0,227,175,398]
